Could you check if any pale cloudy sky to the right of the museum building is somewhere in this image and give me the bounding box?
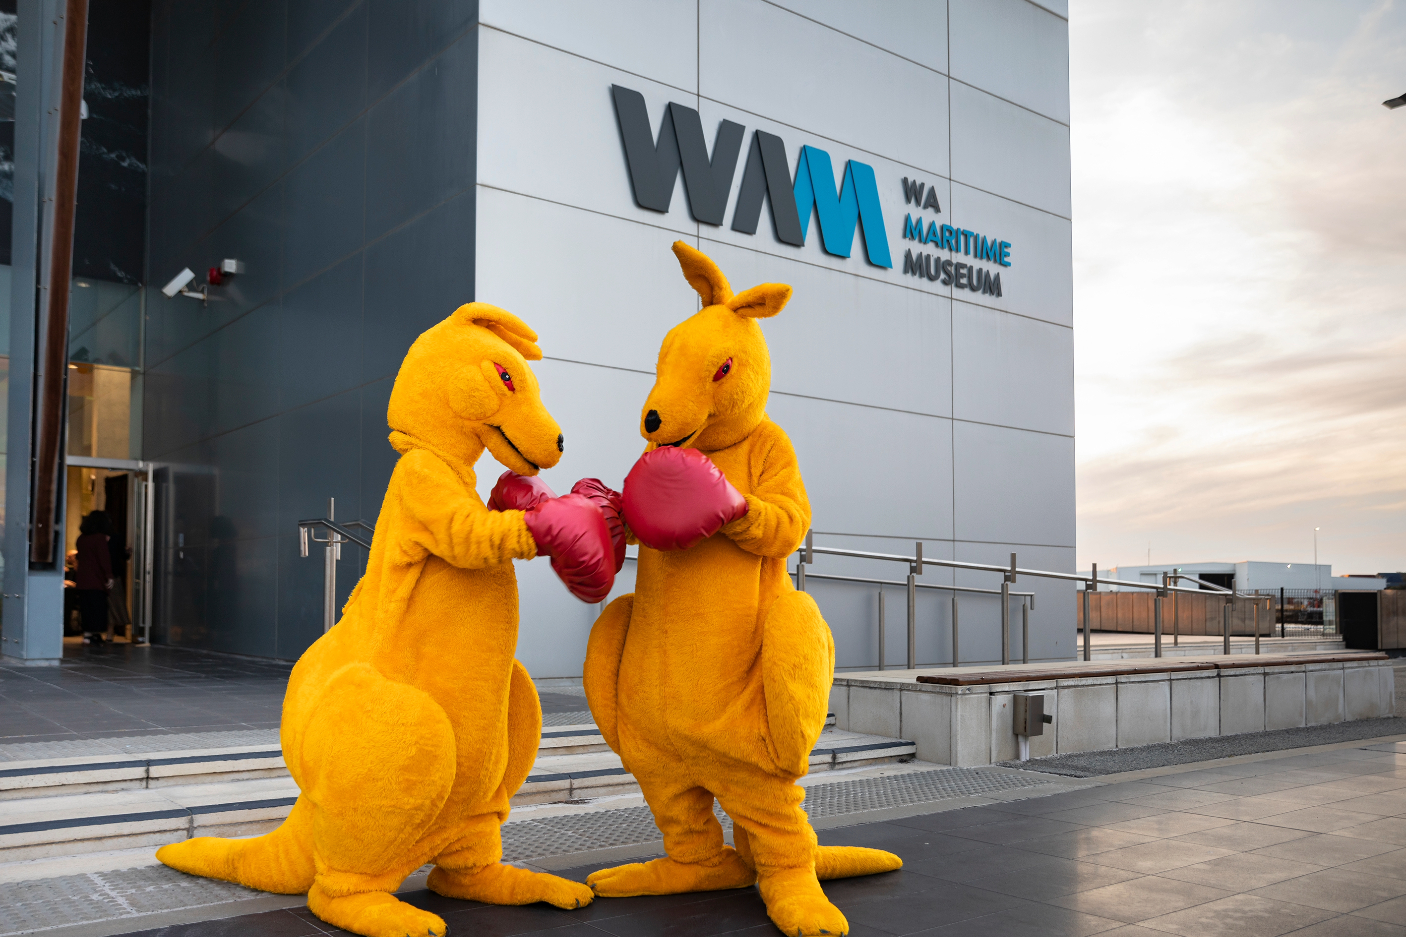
[1070,0,1406,575]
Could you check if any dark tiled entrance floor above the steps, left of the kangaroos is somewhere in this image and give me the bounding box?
[0,644,585,744]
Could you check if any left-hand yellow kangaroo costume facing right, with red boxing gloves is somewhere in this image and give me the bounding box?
[156,302,614,937]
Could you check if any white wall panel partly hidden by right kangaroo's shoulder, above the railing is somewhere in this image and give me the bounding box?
[766,393,952,539]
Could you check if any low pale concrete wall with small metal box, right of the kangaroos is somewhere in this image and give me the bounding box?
[830,660,1396,765]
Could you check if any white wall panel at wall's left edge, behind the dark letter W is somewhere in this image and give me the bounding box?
[478,30,697,234]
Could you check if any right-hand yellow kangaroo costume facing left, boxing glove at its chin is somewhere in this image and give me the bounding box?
[585,241,903,934]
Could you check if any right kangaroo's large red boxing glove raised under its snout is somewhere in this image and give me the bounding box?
[621,446,747,550]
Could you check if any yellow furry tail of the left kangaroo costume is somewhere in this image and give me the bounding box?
[156,798,315,895]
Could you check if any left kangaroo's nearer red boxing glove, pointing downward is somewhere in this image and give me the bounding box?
[523,494,614,602]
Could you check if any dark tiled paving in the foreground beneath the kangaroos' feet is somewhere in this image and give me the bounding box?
[109,743,1406,937]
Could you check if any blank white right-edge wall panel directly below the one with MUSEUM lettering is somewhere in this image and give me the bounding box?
[952,302,1074,436]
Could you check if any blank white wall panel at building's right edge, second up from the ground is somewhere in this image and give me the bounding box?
[952,421,1074,547]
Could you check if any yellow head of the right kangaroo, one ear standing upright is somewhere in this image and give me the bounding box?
[640,241,790,452]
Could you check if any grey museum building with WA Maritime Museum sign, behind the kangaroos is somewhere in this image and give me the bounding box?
[0,0,1076,681]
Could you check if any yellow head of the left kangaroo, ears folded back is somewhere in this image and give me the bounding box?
[387,302,564,476]
